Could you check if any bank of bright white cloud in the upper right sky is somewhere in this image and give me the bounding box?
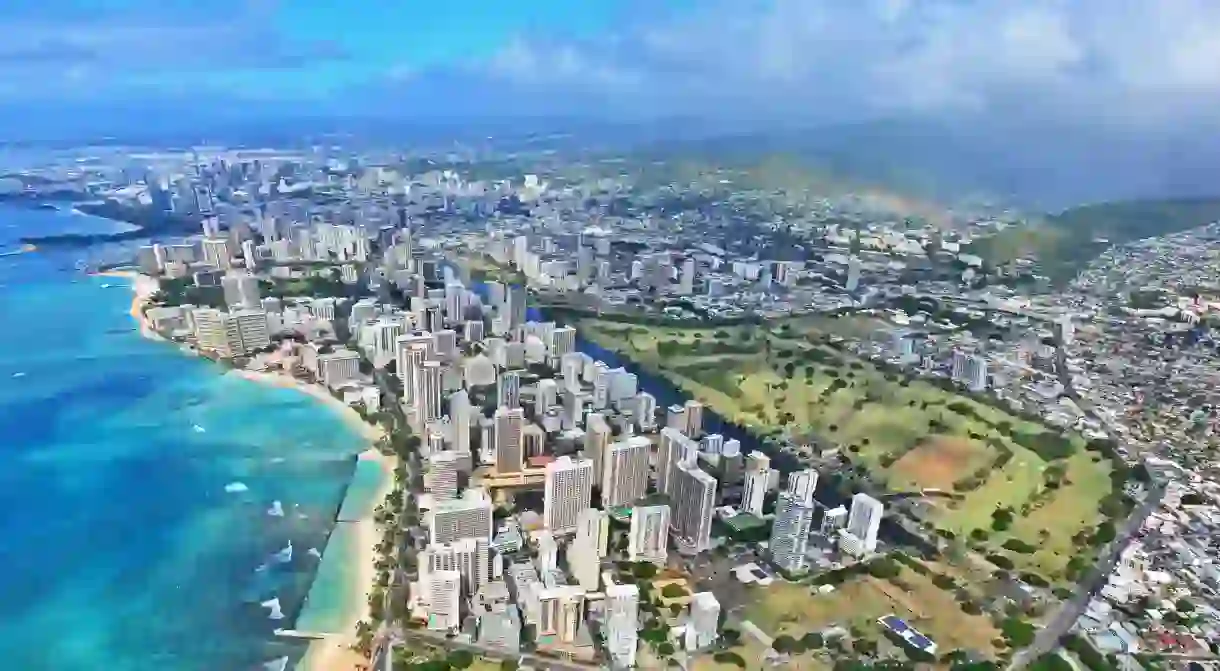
[478,0,1220,128]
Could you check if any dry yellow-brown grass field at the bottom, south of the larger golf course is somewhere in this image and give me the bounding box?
[745,567,999,655]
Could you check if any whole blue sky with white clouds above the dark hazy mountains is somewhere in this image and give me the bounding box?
[0,0,1220,137]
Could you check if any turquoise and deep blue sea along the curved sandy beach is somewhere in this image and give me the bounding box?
[0,207,366,671]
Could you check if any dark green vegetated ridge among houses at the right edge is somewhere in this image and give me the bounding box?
[969,198,1220,282]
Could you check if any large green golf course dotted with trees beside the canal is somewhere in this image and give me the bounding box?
[578,320,1111,581]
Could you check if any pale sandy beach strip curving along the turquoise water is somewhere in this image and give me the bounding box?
[107,271,398,671]
